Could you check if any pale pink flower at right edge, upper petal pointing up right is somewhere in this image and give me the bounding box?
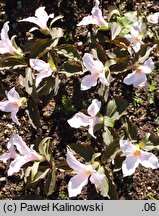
[123,58,154,87]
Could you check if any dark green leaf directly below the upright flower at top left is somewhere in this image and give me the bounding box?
[30,38,54,59]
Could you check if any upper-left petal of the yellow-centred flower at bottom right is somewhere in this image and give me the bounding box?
[119,140,136,157]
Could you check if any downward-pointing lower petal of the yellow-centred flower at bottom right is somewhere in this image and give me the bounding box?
[122,156,139,177]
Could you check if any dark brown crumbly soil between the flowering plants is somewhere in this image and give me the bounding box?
[0,0,159,199]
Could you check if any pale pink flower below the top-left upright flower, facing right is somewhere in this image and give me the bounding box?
[30,59,53,87]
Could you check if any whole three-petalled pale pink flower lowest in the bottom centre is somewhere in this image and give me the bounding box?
[66,148,106,197]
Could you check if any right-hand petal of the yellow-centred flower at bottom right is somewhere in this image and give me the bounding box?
[140,150,159,169]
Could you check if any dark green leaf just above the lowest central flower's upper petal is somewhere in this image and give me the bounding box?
[68,143,94,162]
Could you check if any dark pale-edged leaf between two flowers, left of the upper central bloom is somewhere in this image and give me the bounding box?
[59,61,82,76]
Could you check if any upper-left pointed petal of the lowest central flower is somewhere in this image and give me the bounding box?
[66,148,85,171]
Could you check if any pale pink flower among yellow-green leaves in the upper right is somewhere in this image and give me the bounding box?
[124,20,143,52]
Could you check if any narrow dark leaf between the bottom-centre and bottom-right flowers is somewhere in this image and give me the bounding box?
[101,140,119,163]
